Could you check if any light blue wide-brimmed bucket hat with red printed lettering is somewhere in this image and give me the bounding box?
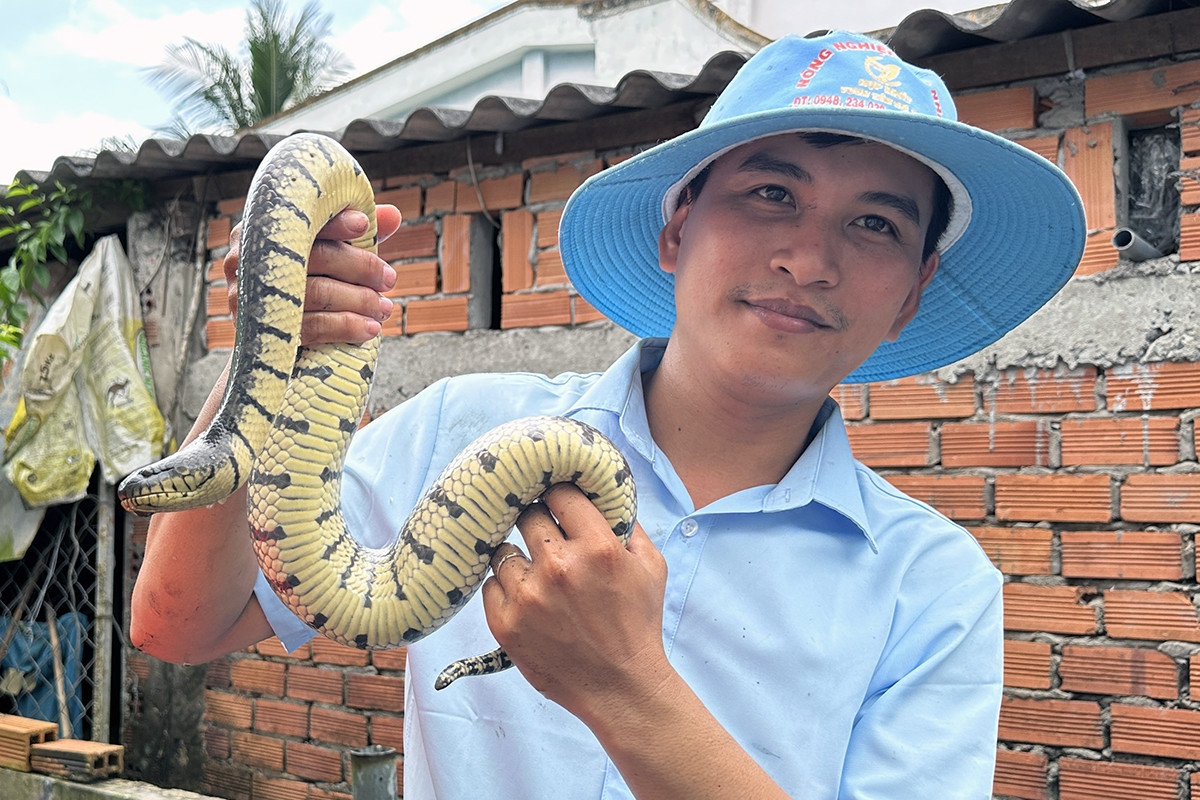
[559,31,1086,383]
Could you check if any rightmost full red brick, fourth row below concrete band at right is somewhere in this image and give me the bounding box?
[1061,530,1183,581]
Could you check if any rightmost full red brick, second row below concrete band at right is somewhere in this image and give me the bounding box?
[1062,416,1180,467]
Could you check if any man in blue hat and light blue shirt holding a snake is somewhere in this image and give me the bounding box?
[133,32,1084,799]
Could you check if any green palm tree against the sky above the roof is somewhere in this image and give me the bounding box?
[148,0,350,138]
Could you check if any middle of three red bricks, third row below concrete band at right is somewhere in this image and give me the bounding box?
[996,474,1112,522]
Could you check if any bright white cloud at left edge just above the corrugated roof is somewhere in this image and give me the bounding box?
[0,97,151,186]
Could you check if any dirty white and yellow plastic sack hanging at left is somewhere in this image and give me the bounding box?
[5,236,163,506]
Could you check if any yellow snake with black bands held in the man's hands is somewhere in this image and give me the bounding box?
[118,133,637,690]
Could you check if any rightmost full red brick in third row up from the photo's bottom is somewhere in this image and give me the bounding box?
[1058,644,1180,700]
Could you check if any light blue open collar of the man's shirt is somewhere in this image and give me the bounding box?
[569,338,878,552]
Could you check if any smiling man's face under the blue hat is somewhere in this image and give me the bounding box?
[660,134,937,396]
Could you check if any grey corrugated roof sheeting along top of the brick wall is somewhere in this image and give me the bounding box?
[11,0,1200,182]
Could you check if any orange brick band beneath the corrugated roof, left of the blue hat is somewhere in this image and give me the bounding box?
[206,152,620,349]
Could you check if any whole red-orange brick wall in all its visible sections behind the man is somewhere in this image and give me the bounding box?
[171,51,1200,800]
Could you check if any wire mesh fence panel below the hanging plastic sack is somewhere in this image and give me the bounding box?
[0,477,114,741]
